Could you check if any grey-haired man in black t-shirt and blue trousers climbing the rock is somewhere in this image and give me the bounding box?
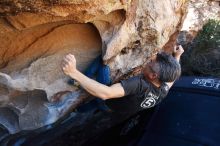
[62,45,184,113]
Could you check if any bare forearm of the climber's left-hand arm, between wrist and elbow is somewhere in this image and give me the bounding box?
[70,70,111,99]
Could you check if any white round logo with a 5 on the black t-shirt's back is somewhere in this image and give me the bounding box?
[141,92,159,108]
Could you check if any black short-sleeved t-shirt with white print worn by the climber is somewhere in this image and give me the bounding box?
[105,74,169,114]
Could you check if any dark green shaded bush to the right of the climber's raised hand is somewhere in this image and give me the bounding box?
[182,20,220,77]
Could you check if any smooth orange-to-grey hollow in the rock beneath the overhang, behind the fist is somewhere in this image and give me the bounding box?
[0,22,101,97]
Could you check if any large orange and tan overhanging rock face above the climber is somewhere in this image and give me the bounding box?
[0,0,187,132]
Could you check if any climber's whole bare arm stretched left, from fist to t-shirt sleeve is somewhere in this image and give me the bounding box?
[62,54,125,100]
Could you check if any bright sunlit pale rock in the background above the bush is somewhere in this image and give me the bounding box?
[178,0,220,47]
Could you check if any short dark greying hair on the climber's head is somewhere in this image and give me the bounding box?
[156,52,181,82]
